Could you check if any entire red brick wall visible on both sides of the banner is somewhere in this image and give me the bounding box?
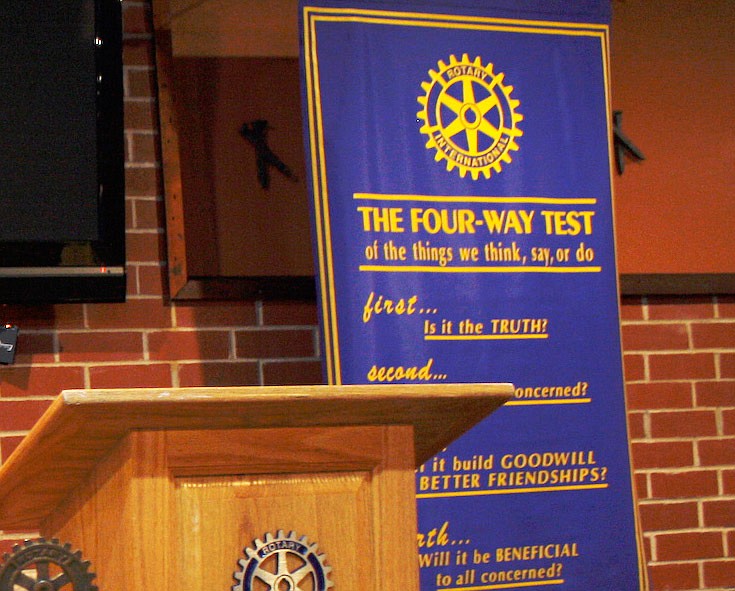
[0,0,735,591]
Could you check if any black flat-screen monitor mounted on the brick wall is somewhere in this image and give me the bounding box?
[0,0,125,304]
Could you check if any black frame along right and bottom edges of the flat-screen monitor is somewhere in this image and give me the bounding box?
[0,0,126,304]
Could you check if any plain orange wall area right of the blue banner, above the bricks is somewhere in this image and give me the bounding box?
[611,0,735,274]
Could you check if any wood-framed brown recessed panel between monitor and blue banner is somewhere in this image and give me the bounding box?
[153,0,315,300]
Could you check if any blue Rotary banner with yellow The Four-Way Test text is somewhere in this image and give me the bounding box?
[300,0,645,591]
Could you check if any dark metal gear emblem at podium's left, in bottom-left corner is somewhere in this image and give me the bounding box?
[0,538,97,591]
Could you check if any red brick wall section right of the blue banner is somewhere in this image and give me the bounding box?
[622,297,735,590]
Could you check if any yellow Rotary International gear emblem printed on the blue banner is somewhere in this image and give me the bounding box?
[416,53,523,180]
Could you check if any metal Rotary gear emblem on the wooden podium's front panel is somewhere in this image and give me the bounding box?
[232,530,333,591]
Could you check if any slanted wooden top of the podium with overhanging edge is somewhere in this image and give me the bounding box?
[0,384,513,531]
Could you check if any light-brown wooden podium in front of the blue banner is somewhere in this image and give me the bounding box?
[0,384,513,591]
